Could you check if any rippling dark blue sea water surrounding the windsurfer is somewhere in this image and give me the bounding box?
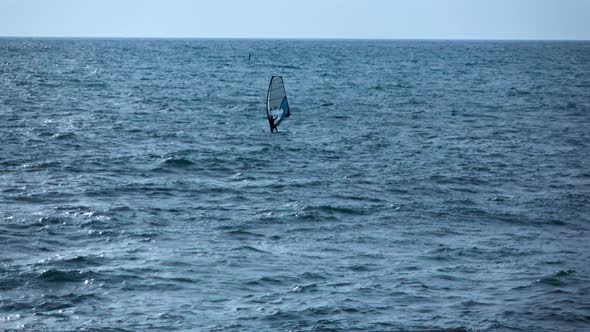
[0,39,590,331]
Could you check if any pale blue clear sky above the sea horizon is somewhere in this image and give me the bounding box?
[0,0,590,40]
